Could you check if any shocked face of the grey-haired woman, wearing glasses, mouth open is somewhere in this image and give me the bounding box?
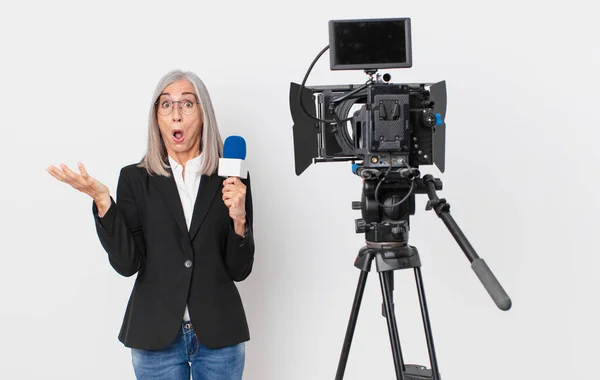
[156,79,203,158]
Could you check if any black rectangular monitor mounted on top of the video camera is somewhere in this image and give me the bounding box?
[329,18,412,70]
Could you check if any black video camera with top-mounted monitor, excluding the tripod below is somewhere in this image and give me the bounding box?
[290,18,446,175]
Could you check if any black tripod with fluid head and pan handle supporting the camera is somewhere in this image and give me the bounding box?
[335,175,511,380]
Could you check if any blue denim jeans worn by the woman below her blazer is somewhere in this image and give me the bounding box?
[131,322,245,380]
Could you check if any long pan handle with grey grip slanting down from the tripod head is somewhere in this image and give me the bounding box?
[423,174,512,311]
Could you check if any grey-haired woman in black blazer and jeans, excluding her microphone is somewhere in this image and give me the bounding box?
[47,70,254,380]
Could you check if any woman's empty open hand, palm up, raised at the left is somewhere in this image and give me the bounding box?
[46,162,111,217]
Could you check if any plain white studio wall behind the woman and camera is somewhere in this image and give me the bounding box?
[0,0,600,380]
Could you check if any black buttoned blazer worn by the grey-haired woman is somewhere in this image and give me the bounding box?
[92,164,254,350]
